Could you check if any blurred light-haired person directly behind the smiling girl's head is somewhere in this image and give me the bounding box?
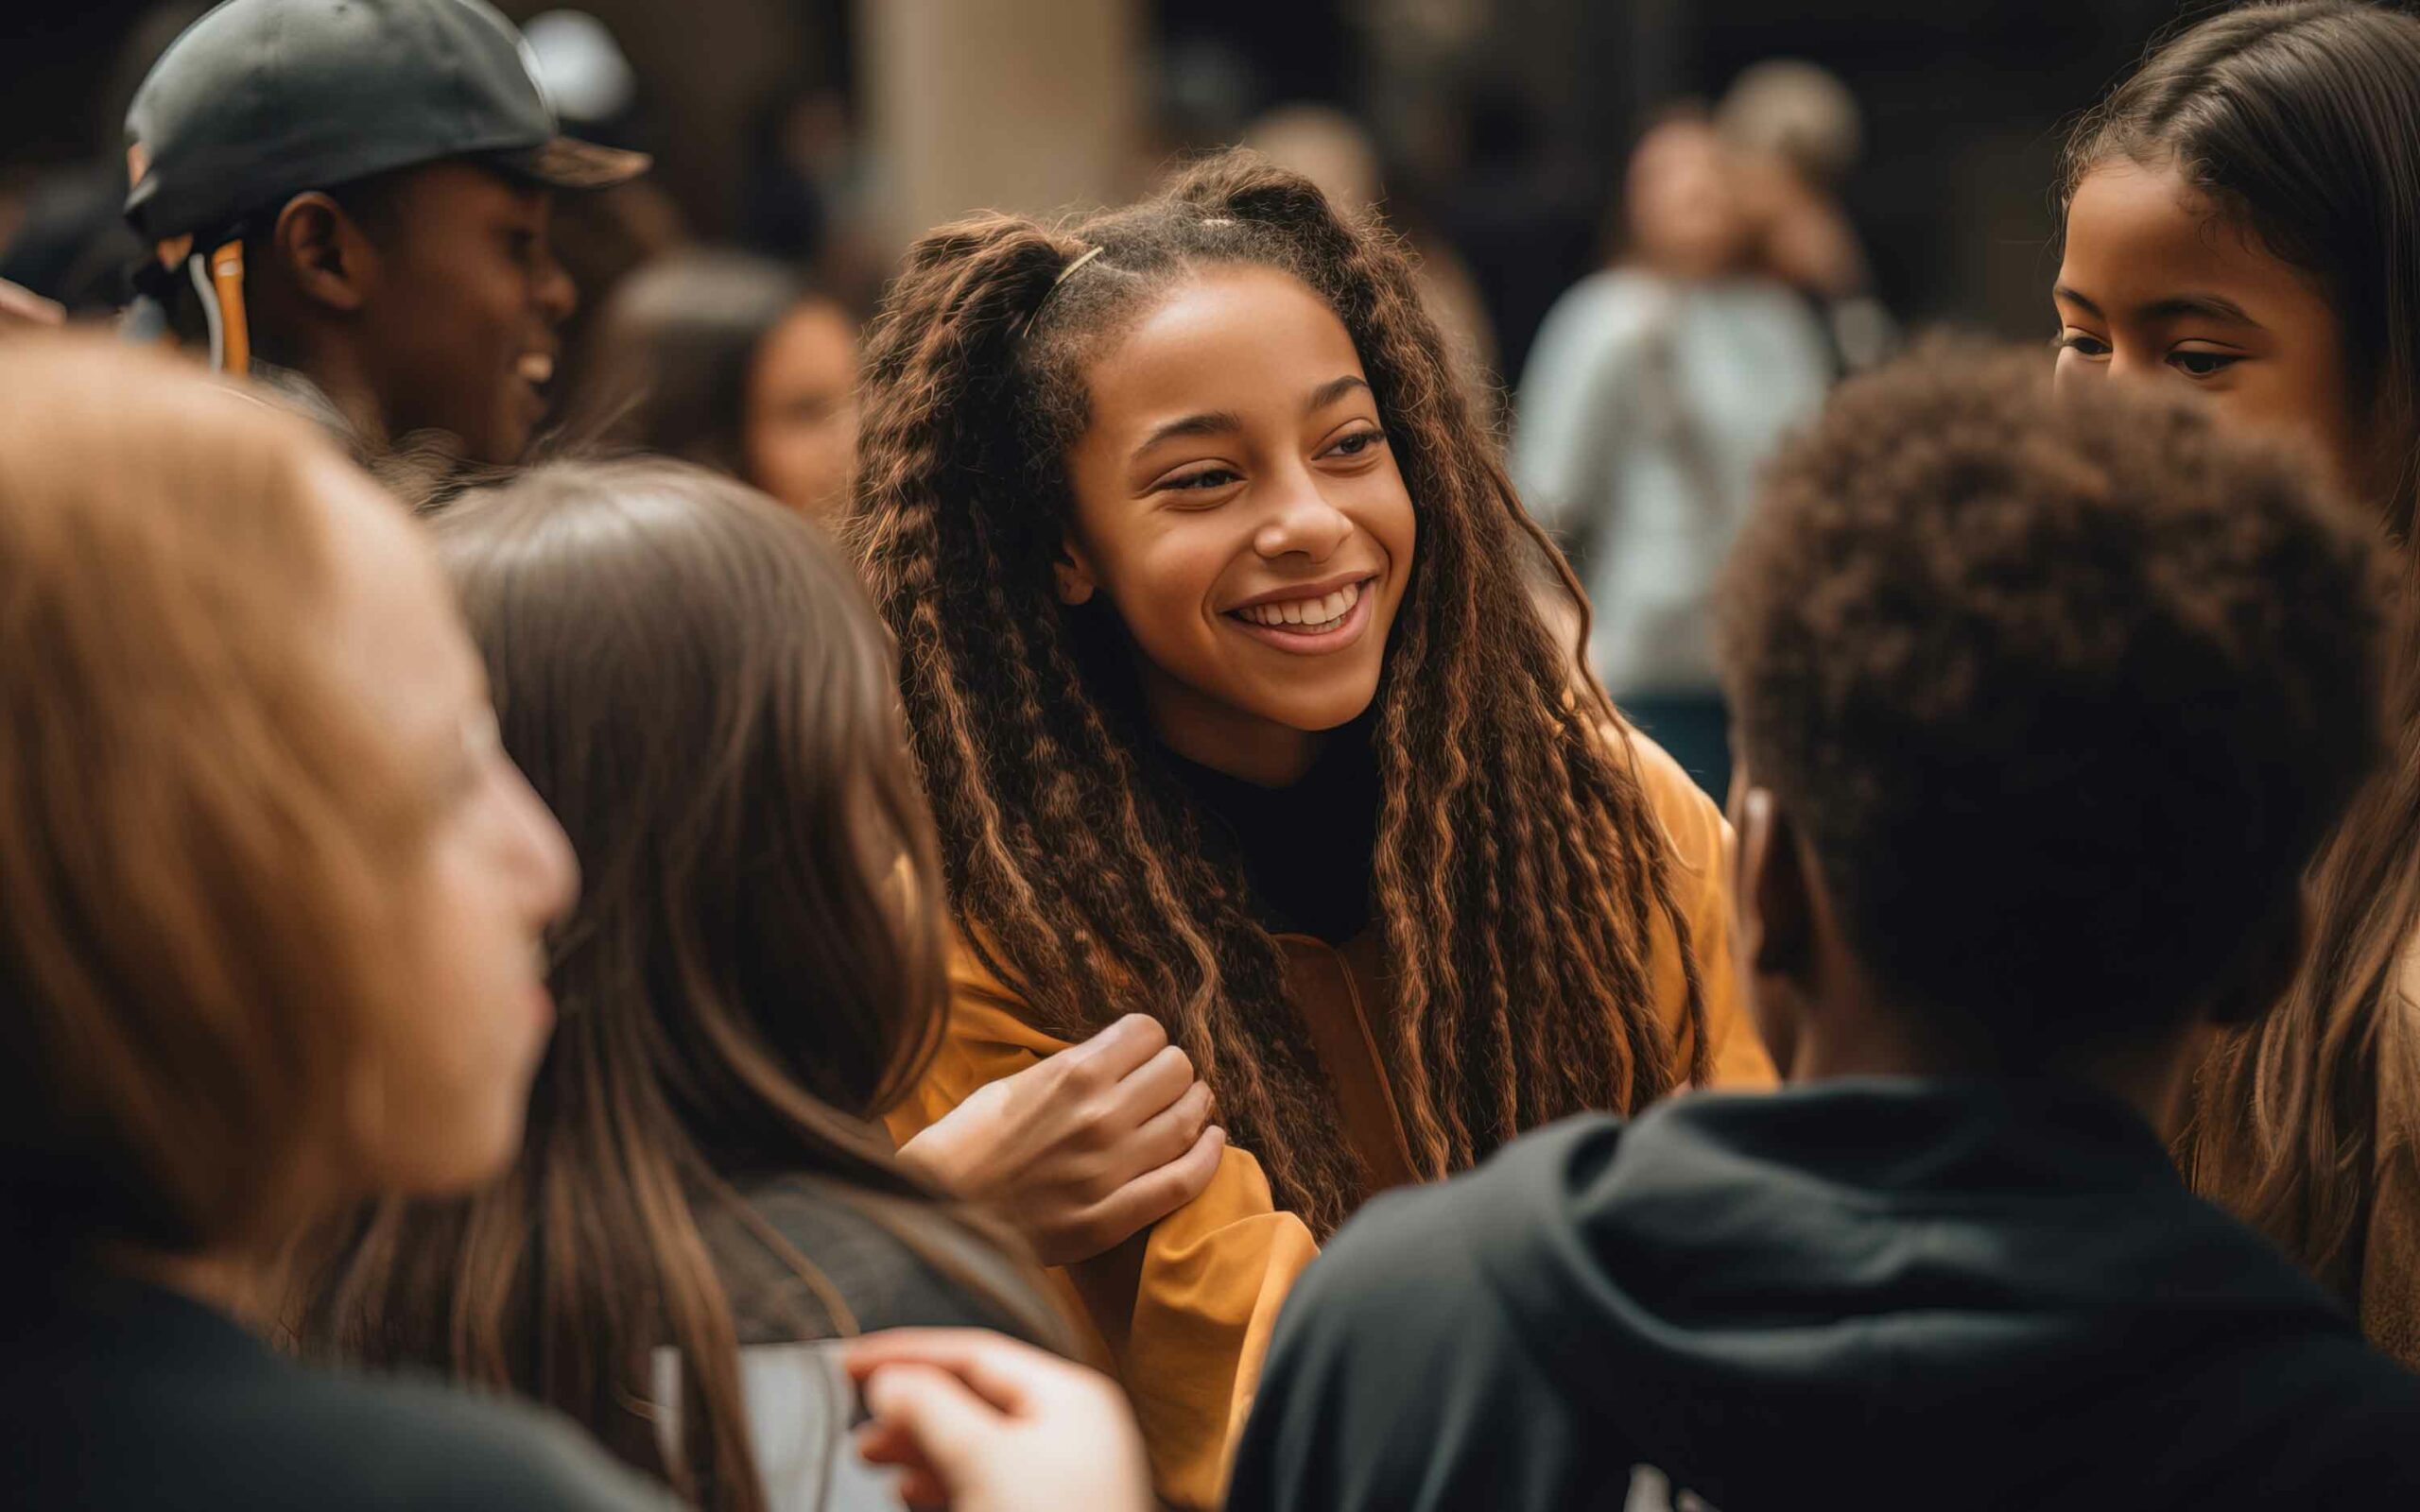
[1241,104,1503,423]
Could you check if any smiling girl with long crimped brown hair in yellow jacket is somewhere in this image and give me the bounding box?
[852,155,1772,1504]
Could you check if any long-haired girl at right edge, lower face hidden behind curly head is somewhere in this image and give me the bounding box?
[2052,0,2420,1365]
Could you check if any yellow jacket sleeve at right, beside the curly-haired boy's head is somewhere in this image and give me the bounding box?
[1621,729,1773,1089]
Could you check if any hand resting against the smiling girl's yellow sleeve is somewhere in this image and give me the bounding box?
[900,1014,1227,1265]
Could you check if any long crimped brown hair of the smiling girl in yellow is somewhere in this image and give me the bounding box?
[850,152,1708,1234]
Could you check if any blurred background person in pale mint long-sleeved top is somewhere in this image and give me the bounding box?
[1512,116,1832,796]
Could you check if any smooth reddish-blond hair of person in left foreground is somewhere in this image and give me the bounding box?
[0,336,421,1251]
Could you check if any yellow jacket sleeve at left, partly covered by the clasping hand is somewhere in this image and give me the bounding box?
[889,949,1319,1507]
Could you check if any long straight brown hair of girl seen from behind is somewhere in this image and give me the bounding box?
[302,462,1063,1509]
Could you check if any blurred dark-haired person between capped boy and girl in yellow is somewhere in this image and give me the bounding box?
[571,251,856,520]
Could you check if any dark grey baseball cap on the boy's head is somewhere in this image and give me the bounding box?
[126,0,648,242]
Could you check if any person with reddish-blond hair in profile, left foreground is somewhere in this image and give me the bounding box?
[0,336,663,1512]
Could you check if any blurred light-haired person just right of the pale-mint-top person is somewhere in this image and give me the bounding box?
[1713,58,1897,372]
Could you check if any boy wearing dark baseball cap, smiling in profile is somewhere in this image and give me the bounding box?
[126,0,647,462]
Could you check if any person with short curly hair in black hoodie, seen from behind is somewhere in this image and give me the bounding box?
[1227,349,2420,1512]
